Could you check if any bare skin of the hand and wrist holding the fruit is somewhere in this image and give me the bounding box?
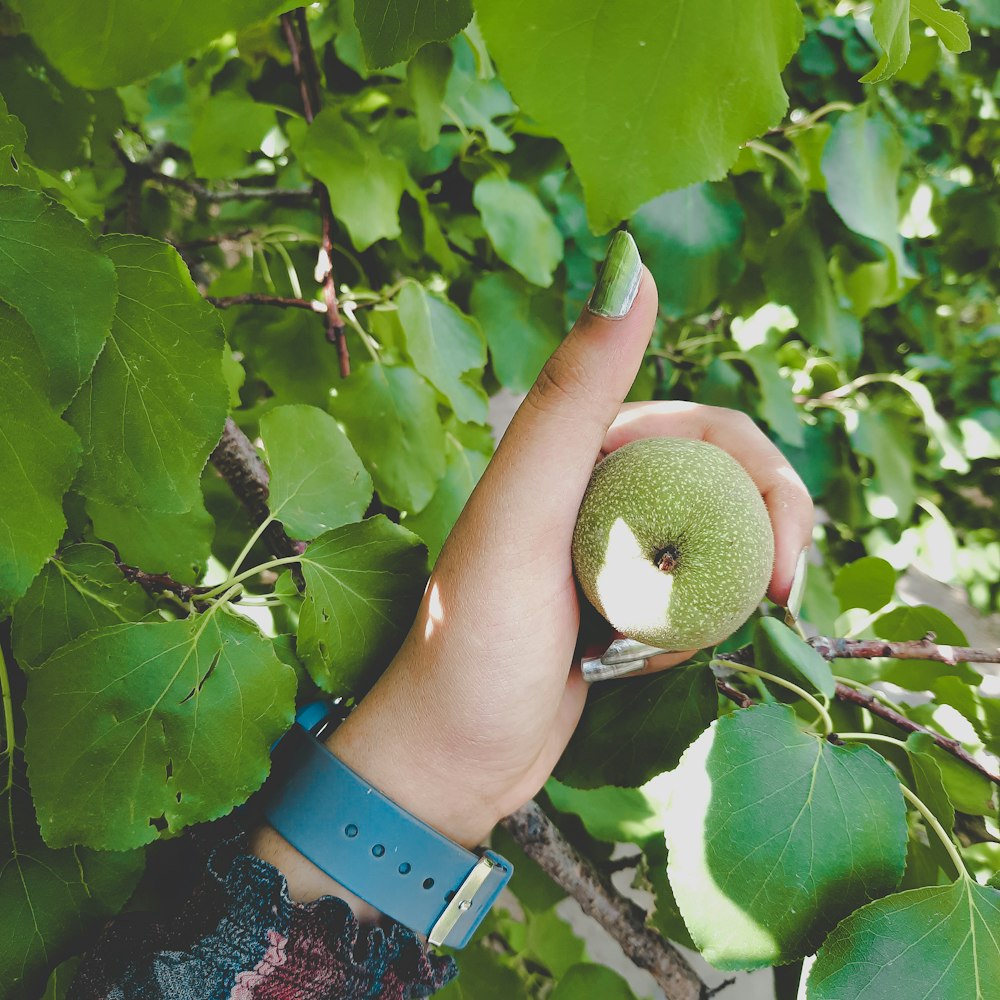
[252,270,813,919]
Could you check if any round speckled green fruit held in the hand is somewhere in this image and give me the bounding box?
[573,438,774,650]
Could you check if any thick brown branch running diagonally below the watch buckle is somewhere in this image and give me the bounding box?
[502,802,709,1000]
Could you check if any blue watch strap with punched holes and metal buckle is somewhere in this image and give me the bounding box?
[261,719,513,948]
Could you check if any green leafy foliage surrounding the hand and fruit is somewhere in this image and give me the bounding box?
[0,0,1000,1000]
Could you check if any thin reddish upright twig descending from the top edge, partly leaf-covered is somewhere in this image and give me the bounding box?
[281,7,351,378]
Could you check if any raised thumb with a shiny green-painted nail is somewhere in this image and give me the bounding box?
[483,230,657,530]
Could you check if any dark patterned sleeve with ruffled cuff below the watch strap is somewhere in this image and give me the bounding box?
[67,838,456,1000]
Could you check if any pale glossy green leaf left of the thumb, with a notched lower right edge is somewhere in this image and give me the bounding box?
[396,281,487,424]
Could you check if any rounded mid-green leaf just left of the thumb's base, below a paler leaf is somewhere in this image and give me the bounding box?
[330,362,445,513]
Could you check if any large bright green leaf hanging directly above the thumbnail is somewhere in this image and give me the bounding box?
[476,0,802,232]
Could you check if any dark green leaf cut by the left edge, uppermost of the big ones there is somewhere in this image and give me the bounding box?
[0,187,116,410]
